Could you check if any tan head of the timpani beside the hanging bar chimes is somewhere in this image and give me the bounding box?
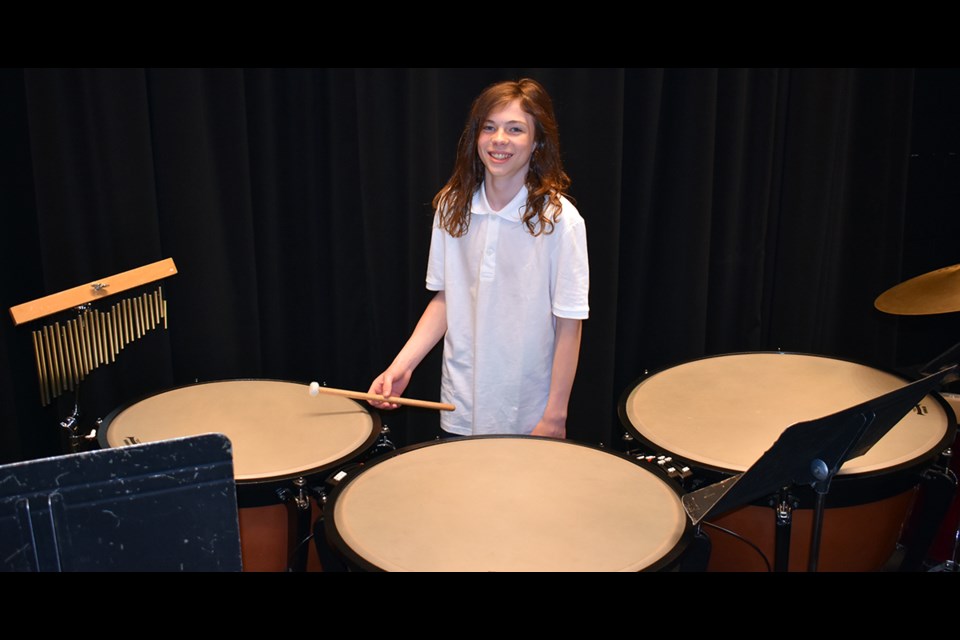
[97,380,380,485]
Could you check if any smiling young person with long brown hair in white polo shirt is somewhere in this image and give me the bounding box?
[370,79,589,438]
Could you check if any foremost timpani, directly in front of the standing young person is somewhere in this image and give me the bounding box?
[324,436,690,572]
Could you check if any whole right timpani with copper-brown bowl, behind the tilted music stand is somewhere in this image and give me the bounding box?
[618,352,956,571]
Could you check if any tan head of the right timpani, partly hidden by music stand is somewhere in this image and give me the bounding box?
[621,352,955,477]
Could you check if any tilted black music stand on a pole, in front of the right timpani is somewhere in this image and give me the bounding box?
[682,365,957,571]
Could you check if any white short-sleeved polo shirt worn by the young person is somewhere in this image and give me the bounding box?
[427,187,590,435]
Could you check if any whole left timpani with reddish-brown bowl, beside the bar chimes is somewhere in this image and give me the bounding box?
[97,380,381,571]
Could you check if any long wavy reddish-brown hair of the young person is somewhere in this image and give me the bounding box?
[433,78,570,237]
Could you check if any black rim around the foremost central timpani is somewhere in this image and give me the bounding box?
[324,434,693,572]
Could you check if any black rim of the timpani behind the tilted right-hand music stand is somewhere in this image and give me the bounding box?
[617,351,957,498]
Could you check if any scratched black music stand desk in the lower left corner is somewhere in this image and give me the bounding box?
[0,434,242,572]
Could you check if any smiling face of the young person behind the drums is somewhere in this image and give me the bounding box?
[477,98,536,191]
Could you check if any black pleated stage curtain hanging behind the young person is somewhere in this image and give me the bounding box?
[0,68,960,462]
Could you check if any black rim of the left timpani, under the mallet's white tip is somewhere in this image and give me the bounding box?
[97,378,382,506]
